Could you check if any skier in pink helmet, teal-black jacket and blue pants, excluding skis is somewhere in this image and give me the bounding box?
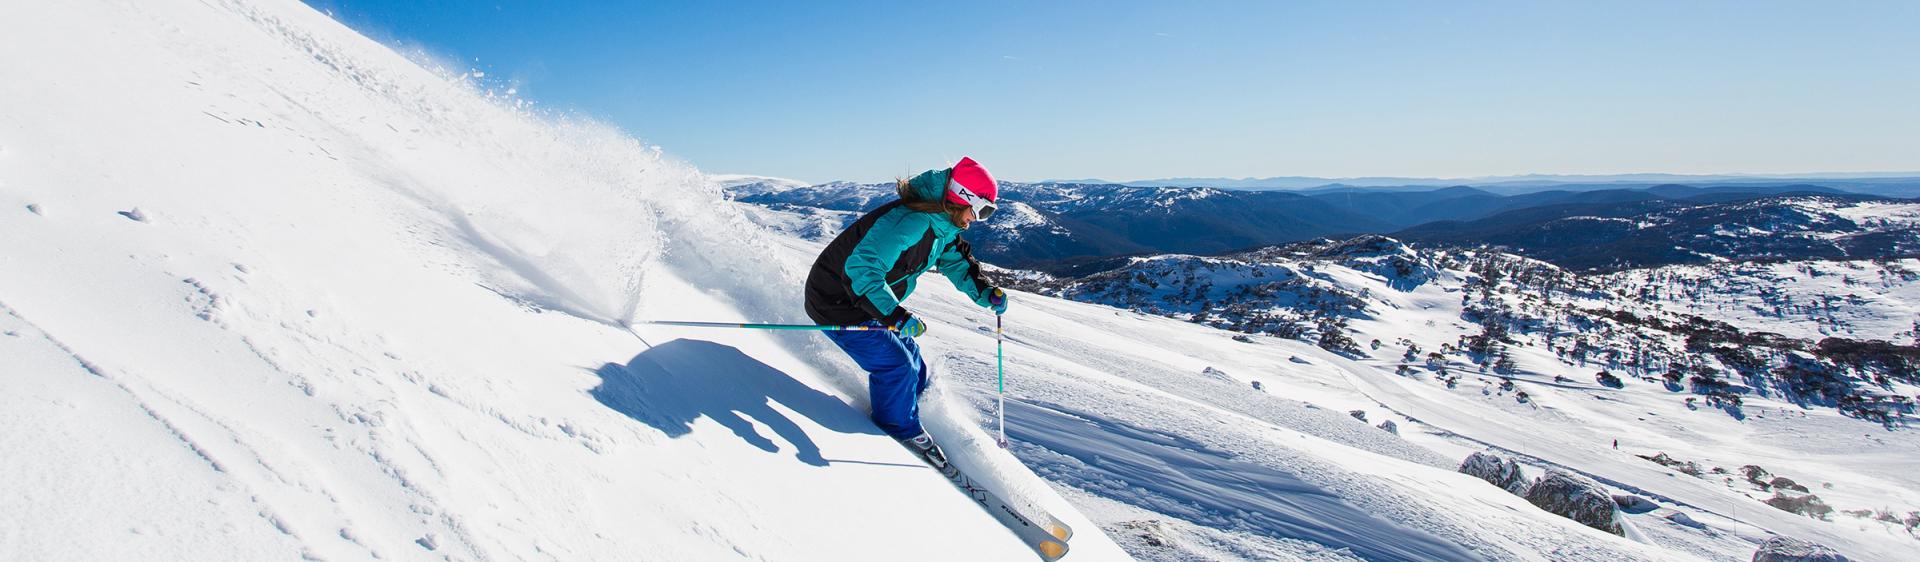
[806,157,1006,468]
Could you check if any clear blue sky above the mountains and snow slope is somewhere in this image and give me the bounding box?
[305,0,1920,180]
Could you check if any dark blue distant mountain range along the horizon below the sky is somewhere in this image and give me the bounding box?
[722,178,1920,270]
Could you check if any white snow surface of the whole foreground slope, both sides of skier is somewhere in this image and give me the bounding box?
[0,0,1914,560]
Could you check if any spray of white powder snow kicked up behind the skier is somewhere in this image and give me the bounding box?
[223,0,821,326]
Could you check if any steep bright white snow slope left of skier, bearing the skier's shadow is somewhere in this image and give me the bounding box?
[0,0,1117,560]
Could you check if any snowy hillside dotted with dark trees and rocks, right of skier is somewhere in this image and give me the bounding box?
[975,238,1920,560]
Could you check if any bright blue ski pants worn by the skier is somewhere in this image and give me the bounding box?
[822,322,927,439]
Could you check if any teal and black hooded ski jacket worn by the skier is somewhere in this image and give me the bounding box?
[806,169,993,326]
